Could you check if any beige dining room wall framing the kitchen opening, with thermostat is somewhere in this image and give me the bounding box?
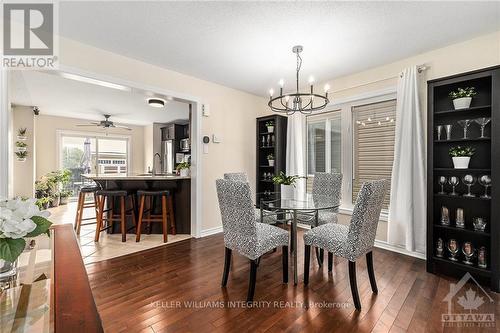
[60,38,266,230]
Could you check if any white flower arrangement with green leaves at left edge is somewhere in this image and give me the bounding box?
[0,198,52,262]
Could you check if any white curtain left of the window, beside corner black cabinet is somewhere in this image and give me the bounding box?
[286,112,306,192]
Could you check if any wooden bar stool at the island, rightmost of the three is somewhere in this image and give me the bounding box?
[135,190,176,243]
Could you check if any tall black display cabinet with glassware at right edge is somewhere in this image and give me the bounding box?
[427,66,500,292]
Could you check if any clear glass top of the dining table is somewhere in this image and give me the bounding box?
[257,192,340,211]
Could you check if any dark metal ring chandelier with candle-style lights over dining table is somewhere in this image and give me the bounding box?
[267,45,330,115]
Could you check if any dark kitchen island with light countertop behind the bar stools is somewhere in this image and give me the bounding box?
[84,174,191,234]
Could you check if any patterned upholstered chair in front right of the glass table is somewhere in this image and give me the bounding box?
[304,180,389,310]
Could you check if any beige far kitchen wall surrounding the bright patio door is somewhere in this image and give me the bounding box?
[35,114,144,179]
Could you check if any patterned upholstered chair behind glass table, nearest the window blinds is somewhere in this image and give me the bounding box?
[298,172,342,266]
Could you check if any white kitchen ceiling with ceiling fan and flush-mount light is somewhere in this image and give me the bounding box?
[11,71,189,125]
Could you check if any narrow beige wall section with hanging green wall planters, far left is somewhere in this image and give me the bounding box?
[12,106,36,198]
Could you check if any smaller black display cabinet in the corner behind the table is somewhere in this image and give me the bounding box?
[255,115,288,201]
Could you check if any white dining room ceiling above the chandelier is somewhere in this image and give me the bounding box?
[59,1,500,95]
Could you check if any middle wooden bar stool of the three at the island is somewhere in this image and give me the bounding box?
[95,190,137,242]
